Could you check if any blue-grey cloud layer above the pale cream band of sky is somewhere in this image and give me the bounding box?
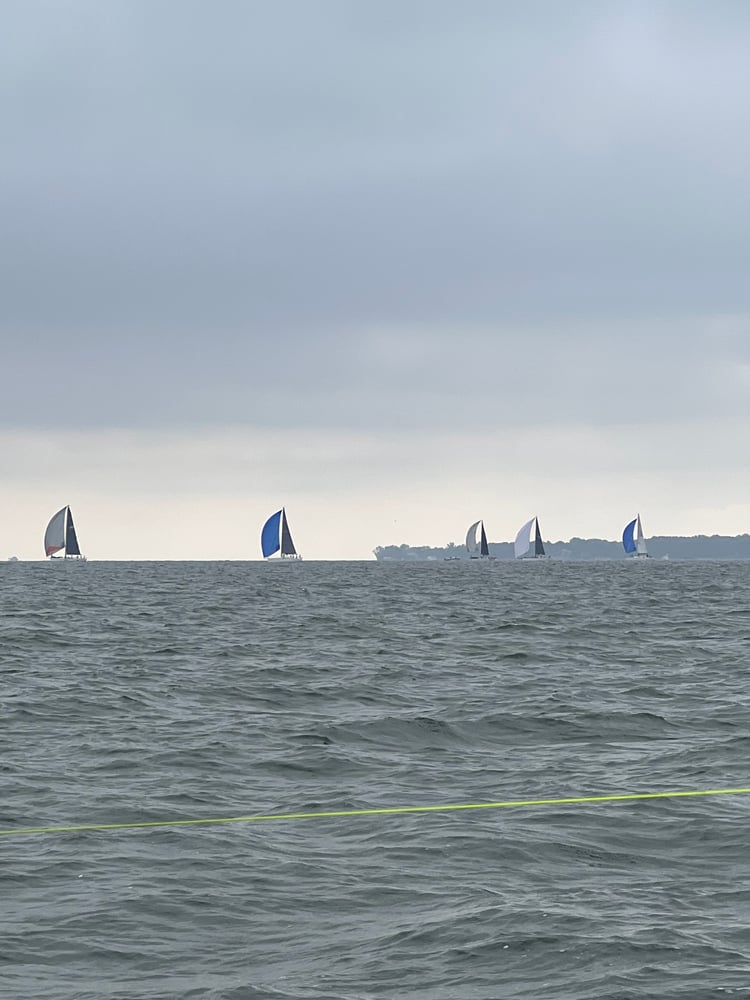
[0,0,750,427]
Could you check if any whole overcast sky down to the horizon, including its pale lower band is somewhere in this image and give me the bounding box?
[0,0,750,559]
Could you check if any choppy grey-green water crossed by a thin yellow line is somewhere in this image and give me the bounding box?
[0,562,750,1000]
